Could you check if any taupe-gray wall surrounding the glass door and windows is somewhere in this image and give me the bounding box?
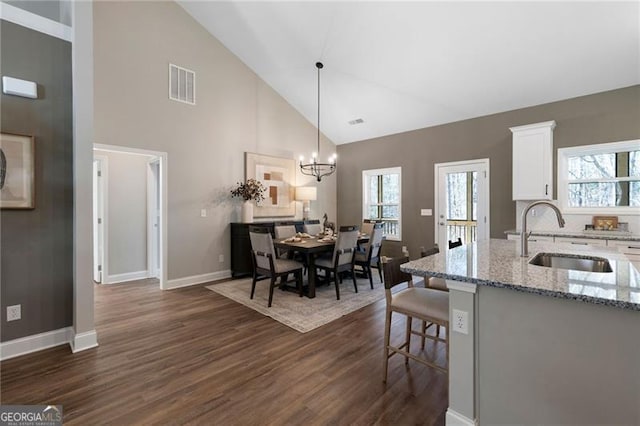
[338,86,640,257]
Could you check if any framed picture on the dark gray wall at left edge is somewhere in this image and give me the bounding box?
[0,133,35,209]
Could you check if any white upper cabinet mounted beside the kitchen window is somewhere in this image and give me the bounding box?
[510,121,556,200]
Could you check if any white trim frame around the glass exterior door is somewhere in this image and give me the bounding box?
[433,158,491,248]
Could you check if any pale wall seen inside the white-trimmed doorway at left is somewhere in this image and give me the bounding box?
[95,150,149,279]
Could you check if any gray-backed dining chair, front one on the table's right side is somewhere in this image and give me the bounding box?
[315,226,358,300]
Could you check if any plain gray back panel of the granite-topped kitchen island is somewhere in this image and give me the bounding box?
[478,286,640,425]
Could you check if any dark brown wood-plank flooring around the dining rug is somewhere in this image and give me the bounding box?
[0,281,447,425]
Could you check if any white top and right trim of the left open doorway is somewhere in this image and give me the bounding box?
[93,143,169,290]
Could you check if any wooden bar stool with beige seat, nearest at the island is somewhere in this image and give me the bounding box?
[382,257,449,382]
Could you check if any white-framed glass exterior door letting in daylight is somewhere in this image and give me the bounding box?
[434,158,490,250]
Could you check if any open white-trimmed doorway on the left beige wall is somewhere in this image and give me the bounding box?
[93,144,167,289]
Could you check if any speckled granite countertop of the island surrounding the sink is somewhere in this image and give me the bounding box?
[401,239,640,311]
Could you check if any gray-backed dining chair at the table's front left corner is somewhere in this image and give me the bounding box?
[249,227,303,307]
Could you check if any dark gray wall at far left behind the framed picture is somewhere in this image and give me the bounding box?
[0,21,73,341]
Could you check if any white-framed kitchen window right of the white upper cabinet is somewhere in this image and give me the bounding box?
[558,140,640,214]
